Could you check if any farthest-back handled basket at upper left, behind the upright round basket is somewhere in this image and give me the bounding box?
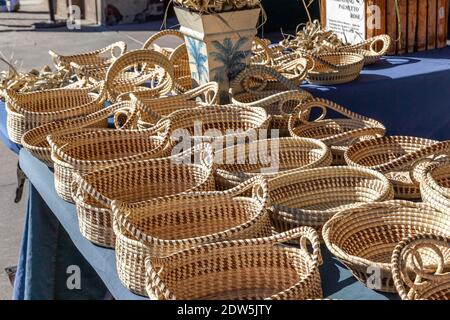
[49,41,127,81]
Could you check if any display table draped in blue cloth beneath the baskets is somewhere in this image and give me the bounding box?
[0,48,450,299]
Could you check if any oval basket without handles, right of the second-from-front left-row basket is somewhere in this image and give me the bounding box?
[269,166,394,231]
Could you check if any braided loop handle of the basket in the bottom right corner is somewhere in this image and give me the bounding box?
[391,234,450,300]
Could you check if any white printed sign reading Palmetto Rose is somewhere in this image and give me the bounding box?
[326,0,366,43]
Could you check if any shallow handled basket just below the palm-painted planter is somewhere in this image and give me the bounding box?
[132,82,219,127]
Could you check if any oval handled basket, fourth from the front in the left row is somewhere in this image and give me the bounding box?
[47,122,170,202]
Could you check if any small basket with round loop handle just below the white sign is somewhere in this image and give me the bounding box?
[338,34,392,65]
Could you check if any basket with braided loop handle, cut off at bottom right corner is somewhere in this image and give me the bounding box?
[391,234,450,300]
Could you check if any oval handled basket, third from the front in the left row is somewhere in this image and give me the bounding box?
[72,144,214,247]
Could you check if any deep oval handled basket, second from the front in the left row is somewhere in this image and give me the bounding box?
[112,177,271,295]
